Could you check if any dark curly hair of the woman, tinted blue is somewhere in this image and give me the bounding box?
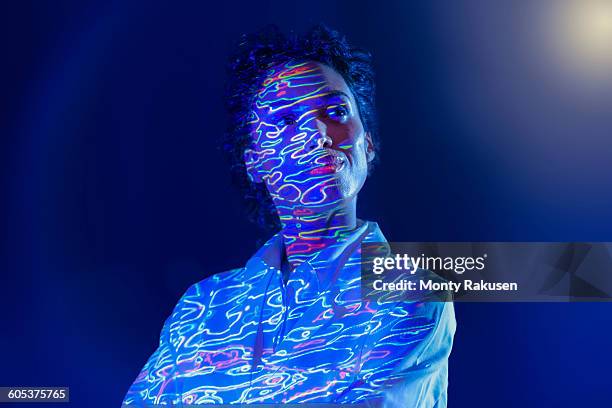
[222,24,379,230]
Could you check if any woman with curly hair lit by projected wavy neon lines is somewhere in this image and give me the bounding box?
[124,26,455,407]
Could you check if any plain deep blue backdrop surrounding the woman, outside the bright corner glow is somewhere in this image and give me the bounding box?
[0,1,612,407]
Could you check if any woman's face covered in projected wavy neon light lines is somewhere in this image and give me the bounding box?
[244,62,374,213]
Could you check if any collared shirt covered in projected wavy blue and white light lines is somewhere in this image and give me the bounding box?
[123,222,455,407]
